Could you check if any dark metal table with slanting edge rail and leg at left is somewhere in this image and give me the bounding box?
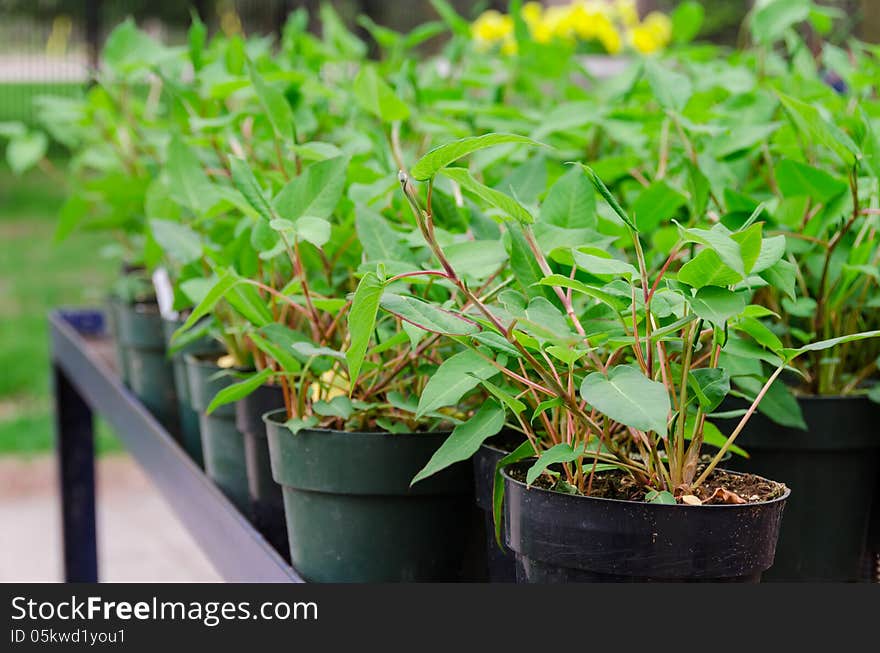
[49,309,303,583]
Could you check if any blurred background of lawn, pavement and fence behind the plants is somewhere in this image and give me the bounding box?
[0,0,880,582]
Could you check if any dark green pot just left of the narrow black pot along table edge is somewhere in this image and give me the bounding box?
[184,354,251,517]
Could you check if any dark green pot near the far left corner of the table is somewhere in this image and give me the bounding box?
[116,303,180,435]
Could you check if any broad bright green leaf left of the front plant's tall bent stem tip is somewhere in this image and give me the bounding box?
[273,156,348,222]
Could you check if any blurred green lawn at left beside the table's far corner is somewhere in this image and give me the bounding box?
[0,163,120,454]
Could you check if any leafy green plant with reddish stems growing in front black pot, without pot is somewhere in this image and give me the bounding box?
[392,136,880,502]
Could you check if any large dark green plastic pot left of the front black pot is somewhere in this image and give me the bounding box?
[265,411,479,582]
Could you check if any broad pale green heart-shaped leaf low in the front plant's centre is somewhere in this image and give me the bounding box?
[581,365,670,437]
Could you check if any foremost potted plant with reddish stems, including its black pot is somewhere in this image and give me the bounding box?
[382,139,878,581]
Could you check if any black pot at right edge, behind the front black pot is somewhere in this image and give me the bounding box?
[730,397,880,582]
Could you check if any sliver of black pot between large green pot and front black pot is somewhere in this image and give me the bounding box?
[473,431,523,583]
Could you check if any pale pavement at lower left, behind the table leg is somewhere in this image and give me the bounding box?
[0,455,221,583]
